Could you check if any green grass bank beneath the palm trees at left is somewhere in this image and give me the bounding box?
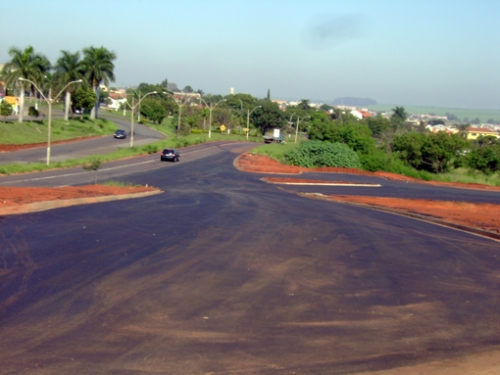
[0,118,118,145]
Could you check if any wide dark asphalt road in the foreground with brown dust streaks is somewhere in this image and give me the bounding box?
[0,144,500,375]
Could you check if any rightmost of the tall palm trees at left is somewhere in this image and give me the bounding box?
[83,47,116,120]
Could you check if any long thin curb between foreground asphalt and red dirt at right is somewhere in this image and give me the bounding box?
[299,193,500,241]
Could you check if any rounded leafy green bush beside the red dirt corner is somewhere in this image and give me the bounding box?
[284,141,361,168]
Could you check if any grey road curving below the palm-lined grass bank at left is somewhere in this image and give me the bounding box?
[0,113,165,165]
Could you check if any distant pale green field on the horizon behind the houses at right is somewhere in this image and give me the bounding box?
[368,104,500,123]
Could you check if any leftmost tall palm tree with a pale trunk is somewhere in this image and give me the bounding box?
[2,46,50,122]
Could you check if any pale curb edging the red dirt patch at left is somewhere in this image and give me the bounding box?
[0,190,163,216]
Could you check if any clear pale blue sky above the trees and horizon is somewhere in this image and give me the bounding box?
[0,0,500,109]
